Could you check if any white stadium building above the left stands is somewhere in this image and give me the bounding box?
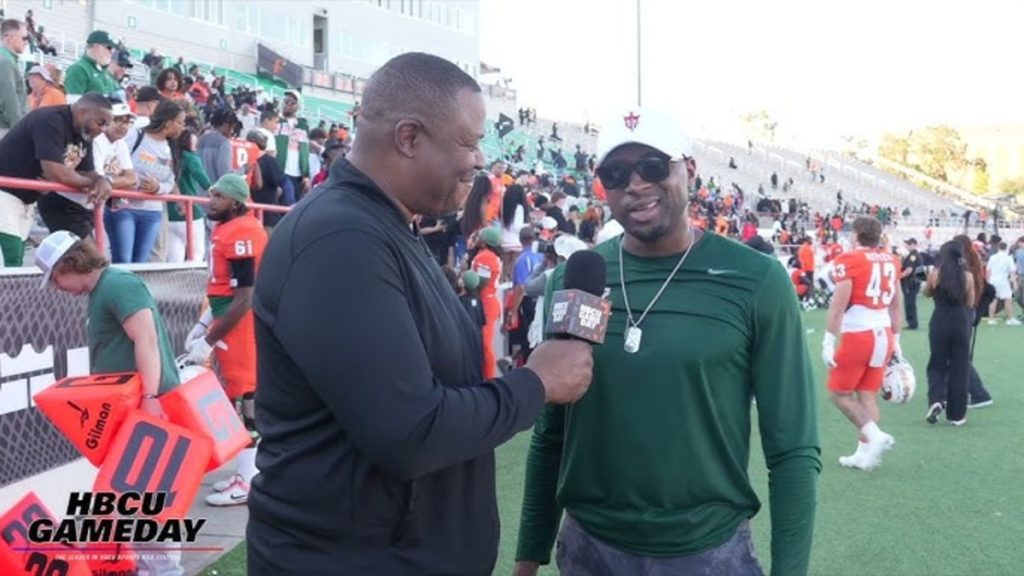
[7,0,479,78]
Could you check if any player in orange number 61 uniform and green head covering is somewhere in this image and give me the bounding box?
[185,174,267,506]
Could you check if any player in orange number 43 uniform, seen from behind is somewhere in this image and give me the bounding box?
[821,216,902,470]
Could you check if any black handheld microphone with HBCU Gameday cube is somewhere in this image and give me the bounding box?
[547,250,611,344]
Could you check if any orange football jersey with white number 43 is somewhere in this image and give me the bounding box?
[833,249,900,310]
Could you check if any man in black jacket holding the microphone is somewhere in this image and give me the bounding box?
[247,52,593,576]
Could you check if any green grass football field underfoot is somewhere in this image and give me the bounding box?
[204,298,1024,576]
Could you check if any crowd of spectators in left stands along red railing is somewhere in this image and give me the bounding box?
[0,20,350,265]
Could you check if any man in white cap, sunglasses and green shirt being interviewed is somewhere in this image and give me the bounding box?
[516,110,821,576]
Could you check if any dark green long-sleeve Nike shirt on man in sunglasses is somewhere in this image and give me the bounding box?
[516,234,821,575]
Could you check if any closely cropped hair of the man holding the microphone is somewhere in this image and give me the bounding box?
[358,52,480,130]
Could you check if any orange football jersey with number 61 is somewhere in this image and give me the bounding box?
[206,214,267,296]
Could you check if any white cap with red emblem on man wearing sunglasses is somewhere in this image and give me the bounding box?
[597,107,693,164]
